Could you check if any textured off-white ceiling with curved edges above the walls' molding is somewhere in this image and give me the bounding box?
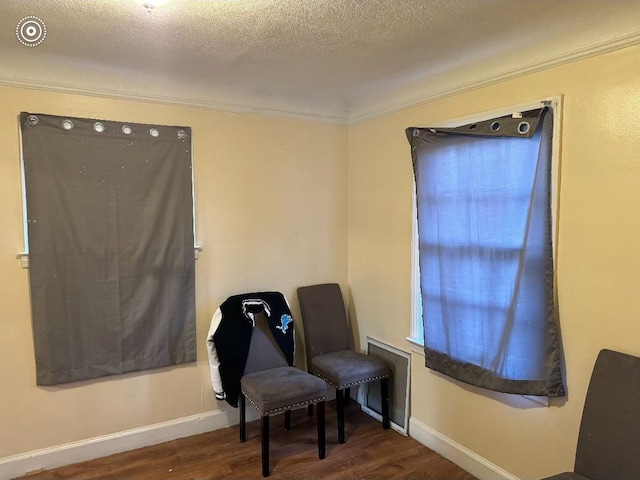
[0,0,640,121]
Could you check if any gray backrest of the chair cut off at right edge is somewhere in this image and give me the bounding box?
[574,350,640,480]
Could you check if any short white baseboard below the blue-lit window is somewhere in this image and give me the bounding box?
[409,417,518,480]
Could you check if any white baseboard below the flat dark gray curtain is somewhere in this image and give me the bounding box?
[0,409,239,480]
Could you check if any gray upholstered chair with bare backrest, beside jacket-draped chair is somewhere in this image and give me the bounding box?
[298,283,389,443]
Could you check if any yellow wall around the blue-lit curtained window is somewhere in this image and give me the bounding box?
[349,43,640,478]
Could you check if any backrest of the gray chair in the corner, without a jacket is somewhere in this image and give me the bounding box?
[298,283,350,362]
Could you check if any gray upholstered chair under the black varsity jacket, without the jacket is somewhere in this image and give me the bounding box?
[238,312,327,477]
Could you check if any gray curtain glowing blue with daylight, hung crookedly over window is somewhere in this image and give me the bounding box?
[406,108,564,397]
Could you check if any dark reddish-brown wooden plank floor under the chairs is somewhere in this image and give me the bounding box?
[17,402,474,480]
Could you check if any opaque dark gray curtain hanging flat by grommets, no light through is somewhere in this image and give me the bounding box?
[20,112,196,385]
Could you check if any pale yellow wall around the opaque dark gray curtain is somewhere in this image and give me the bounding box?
[0,88,348,459]
